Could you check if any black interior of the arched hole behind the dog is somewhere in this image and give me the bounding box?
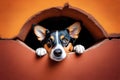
[24,16,96,49]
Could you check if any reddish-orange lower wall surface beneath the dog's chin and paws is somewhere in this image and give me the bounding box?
[0,39,120,80]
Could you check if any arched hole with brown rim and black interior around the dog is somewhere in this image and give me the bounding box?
[16,5,108,50]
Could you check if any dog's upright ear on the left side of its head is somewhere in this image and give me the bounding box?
[34,25,47,41]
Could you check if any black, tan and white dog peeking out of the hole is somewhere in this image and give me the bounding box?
[34,22,85,61]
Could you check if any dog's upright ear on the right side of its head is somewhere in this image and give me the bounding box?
[67,22,81,39]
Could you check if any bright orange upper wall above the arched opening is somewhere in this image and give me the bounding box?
[0,0,120,38]
